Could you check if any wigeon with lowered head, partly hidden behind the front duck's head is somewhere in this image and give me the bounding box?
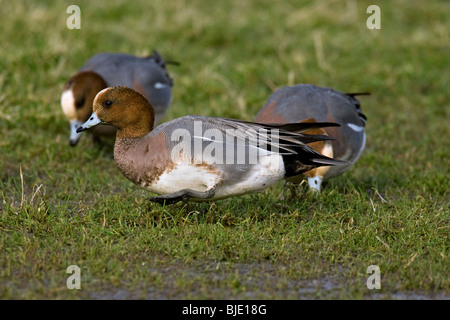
[61,50,173,146]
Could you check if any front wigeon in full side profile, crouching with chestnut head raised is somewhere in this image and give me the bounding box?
[77,86,342,204]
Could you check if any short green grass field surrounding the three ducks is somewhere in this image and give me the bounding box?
[0,0,450,299]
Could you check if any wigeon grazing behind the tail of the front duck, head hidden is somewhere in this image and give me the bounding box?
[255,84,367,192]
